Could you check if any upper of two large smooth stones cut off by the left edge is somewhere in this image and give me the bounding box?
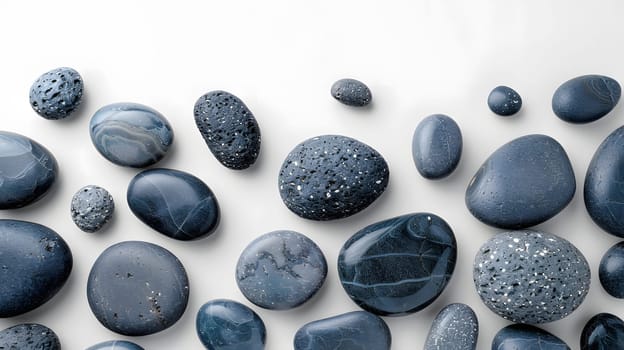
[0,131,58,209]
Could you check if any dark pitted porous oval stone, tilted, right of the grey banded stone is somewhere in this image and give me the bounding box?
[194,91,260,170]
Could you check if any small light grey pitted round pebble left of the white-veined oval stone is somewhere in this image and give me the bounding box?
[71,185,115,232]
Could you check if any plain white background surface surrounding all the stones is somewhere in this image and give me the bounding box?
[0,0,624,350]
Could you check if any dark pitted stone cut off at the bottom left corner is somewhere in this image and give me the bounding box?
[0,323,61,350]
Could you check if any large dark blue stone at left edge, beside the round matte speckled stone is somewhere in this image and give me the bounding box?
[0,219,73,317]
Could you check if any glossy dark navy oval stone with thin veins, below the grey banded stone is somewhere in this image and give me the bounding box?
[127,169,220,241]
